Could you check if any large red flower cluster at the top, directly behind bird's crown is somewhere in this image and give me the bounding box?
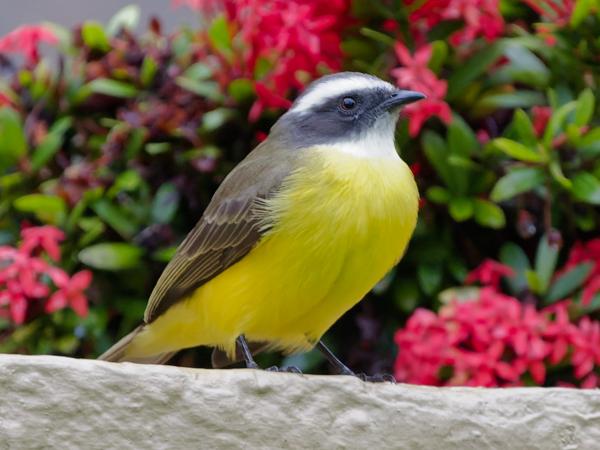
[175,0,351,120]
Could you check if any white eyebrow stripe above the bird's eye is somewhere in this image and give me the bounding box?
[291,76,394,112]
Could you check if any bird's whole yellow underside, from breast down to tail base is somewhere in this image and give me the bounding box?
[128,148,418,357]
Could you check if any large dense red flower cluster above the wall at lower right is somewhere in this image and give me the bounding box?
[395,287,600,388]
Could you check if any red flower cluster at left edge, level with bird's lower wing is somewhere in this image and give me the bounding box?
[0,225,92,325]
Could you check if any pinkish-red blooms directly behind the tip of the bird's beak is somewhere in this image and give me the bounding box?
[391,42,452,136]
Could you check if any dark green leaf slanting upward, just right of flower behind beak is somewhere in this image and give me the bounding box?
[446,39,504,101]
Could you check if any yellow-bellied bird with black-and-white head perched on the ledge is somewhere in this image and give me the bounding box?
[100,72,425,375]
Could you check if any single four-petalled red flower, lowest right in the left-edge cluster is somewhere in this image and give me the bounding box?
[46,269,92,317]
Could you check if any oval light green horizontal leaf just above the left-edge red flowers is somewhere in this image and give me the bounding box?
[79,242,143,270]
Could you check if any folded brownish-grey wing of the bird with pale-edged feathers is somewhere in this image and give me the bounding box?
[144,140,295,323]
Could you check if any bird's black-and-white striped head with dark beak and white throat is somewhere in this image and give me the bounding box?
[272,72,425,155]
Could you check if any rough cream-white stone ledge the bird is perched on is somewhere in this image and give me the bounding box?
[0,355,600,450]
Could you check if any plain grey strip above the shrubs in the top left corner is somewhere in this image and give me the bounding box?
[0,0,196,36]
